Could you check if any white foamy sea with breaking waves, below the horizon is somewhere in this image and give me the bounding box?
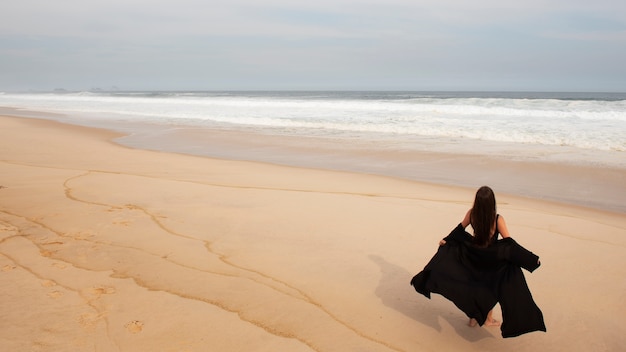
[0,92,626,163]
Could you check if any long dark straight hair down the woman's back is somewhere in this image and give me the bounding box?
[470,186,496,247]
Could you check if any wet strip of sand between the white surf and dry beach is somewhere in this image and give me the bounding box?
[0,107,626,214]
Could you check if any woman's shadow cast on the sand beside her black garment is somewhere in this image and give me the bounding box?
[369,255,500,342]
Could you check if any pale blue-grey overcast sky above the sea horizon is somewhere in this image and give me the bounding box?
[0,0,626,92]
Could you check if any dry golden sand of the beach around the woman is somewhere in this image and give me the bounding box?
[0,117,626,351]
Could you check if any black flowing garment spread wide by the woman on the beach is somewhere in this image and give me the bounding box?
[411,220,546,337]
